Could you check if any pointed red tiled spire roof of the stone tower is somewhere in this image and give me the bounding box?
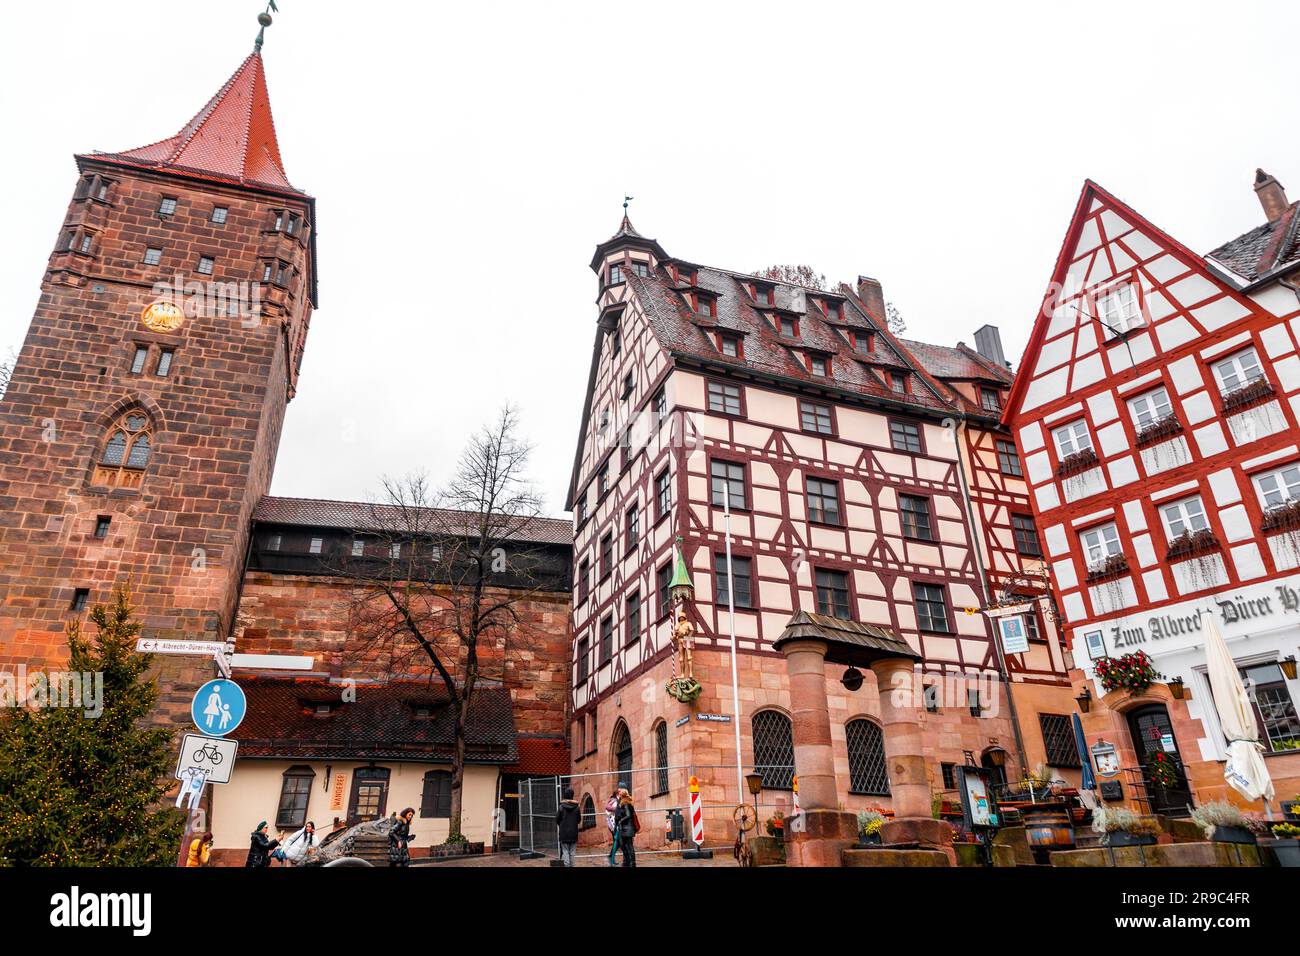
[85,51,296,191]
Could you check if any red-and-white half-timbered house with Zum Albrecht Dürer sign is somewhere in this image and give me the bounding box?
[1005,172,1300,812]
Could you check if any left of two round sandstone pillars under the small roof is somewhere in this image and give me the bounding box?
[781,639,858,866]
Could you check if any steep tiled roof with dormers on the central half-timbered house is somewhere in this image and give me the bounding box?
[628,267,949,410]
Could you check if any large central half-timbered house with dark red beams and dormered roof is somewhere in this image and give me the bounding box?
[569,219,1078,842]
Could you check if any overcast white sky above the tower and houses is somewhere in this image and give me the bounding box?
[0,0,1300,514]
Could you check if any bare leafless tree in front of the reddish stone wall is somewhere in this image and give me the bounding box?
[326,407,547,842]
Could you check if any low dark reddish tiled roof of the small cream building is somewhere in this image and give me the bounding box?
[230,676,520,763]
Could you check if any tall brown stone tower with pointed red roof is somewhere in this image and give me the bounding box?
[0,38,316,712]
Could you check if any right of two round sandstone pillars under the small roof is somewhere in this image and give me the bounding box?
[871,658,957,865]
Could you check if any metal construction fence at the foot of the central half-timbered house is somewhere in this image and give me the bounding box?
[519,763,794,857]
